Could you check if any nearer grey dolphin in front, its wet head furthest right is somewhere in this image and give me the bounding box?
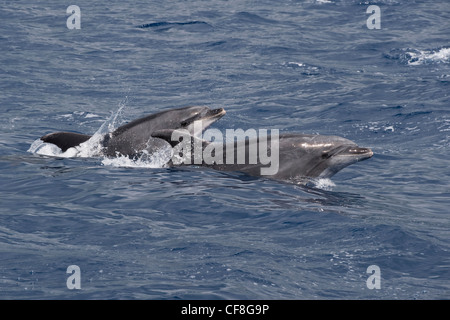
[152,129,373,182]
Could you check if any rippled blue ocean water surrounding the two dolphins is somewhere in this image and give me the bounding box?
[0,0,450,299]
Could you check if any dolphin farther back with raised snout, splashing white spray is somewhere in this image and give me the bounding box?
[40,106,225,158]
